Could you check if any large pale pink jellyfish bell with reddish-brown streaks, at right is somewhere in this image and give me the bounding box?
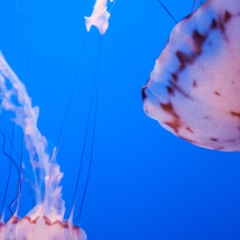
[142,0,240,151]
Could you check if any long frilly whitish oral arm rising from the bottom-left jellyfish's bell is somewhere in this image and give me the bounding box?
[0,52,65,220]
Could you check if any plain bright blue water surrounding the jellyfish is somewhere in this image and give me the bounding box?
[0,0,240,240]
